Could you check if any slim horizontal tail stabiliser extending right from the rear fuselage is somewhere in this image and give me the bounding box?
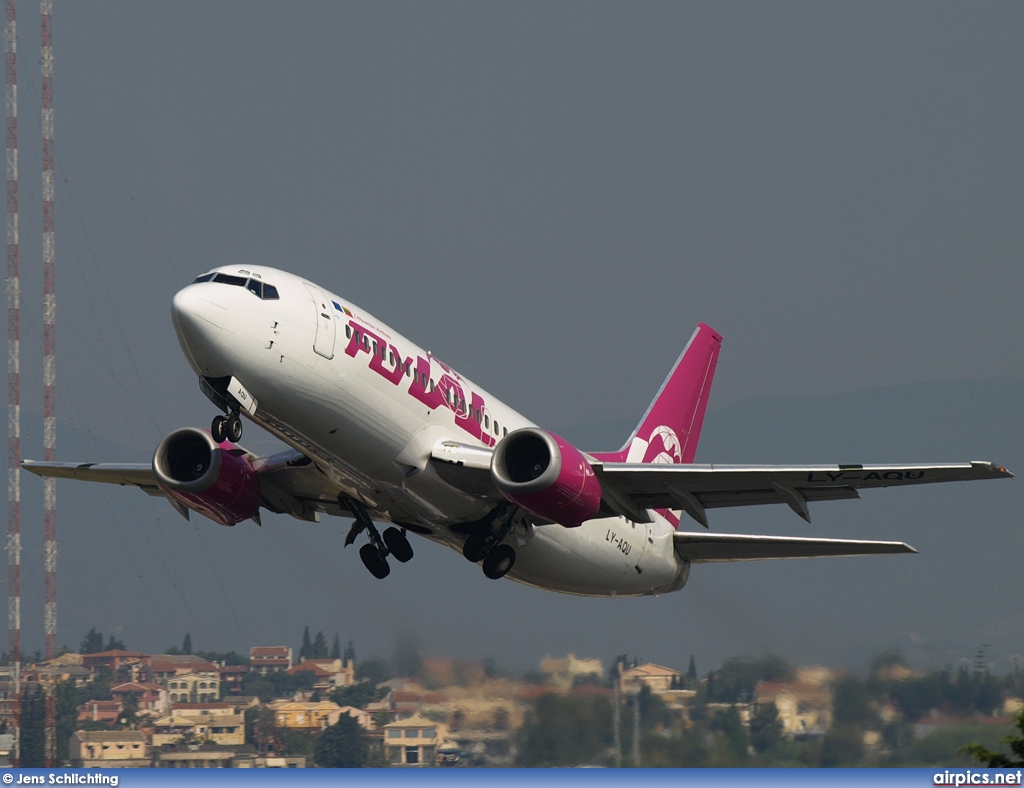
[672,531,918,564]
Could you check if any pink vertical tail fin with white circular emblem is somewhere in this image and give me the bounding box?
[594,323,722,464]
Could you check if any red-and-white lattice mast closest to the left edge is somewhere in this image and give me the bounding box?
[3,0,22,764]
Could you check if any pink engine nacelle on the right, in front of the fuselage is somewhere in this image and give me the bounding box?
[490,427,601,528]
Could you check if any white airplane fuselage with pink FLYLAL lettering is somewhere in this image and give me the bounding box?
[172,267,689,596]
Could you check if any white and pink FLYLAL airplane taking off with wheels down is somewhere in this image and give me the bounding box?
[23,266,1013,597]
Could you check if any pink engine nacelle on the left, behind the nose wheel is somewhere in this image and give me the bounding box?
[153,427,260,525]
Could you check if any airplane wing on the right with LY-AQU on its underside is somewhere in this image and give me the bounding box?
[594,462,1013,528]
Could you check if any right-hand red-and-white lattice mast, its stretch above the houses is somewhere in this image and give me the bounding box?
[39,0,57,659]
